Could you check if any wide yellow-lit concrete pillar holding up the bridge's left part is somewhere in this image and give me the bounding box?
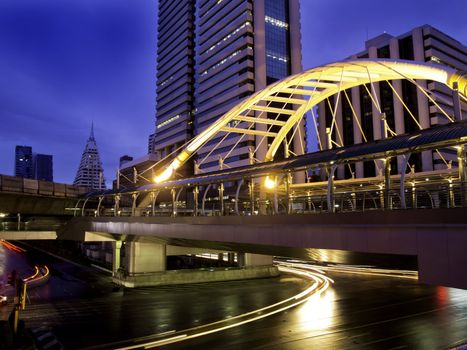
[125,242,166,275]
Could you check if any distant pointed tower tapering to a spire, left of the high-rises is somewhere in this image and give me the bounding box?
[73,123,105,190]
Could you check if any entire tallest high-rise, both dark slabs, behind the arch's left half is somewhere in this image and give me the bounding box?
[153,0,305,172]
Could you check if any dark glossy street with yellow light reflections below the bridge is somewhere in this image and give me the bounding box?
[1,242,467,349]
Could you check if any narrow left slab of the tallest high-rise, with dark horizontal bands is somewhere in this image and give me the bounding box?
[149,0,195,166]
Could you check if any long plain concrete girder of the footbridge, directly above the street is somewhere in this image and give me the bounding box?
[59,208,467,289]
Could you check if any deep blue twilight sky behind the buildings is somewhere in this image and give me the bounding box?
[0,0,467,184]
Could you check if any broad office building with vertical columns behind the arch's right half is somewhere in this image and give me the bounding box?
[319,25,467,178]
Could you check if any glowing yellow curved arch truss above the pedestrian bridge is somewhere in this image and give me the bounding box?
[154,59,467,182]
